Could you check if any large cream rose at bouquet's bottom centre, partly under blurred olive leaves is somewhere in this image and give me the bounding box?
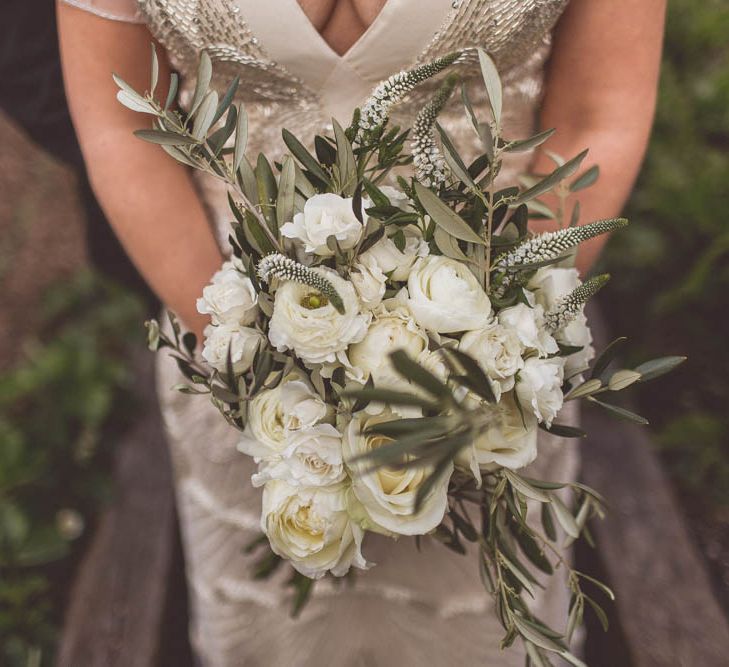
[343,413,452,535]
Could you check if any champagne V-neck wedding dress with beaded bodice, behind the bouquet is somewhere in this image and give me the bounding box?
[65,0,578,667]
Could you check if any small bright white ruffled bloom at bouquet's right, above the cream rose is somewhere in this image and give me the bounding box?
[516,357,564,426]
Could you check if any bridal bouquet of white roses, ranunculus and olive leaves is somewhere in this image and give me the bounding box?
[116,51,682,665]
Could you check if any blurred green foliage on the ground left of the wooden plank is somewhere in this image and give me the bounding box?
[0,273,141,666]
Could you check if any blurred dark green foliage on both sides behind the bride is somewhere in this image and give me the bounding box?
[0,0,729,665]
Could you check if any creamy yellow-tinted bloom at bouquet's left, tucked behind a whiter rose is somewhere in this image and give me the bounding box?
[238,384,287,461]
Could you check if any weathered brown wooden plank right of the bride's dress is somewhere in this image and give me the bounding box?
[583,314,729,667]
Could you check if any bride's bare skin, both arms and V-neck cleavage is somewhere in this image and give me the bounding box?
[58,0,666,335]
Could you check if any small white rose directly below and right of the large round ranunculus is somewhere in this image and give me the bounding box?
[458,322,524,400]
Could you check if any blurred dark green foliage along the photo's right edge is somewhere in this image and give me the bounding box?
[606,0,729,504]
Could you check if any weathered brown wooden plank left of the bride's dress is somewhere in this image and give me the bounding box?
[57,351,175,667]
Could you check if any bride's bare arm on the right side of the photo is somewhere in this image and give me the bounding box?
[533,0,666,272]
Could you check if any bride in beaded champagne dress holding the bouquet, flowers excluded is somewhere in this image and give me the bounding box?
[58,0,665,667]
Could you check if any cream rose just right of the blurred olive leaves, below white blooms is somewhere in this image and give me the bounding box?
[456,394,537,478]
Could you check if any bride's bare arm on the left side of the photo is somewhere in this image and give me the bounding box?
[58,4,222,335]
